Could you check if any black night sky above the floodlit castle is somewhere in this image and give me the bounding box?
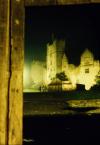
[25,4,100,65]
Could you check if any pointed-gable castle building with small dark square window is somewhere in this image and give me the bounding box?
[78,49,100,90]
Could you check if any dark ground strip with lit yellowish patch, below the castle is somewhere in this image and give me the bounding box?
[24,90,100,116]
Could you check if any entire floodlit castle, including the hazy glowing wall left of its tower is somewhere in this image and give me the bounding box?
[24,40,100,90]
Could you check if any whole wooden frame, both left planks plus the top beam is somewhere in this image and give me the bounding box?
[0,0,100,145]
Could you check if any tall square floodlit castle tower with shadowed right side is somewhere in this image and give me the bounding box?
[47,40,65,84]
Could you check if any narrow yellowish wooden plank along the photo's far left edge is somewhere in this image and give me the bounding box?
[0,0,10,145]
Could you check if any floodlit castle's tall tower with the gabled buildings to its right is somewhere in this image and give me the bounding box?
[46,40,100,90]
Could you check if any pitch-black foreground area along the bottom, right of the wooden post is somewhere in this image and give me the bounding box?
[23,115,100,145]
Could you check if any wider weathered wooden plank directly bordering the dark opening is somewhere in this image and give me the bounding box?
[8,0,24,145]
